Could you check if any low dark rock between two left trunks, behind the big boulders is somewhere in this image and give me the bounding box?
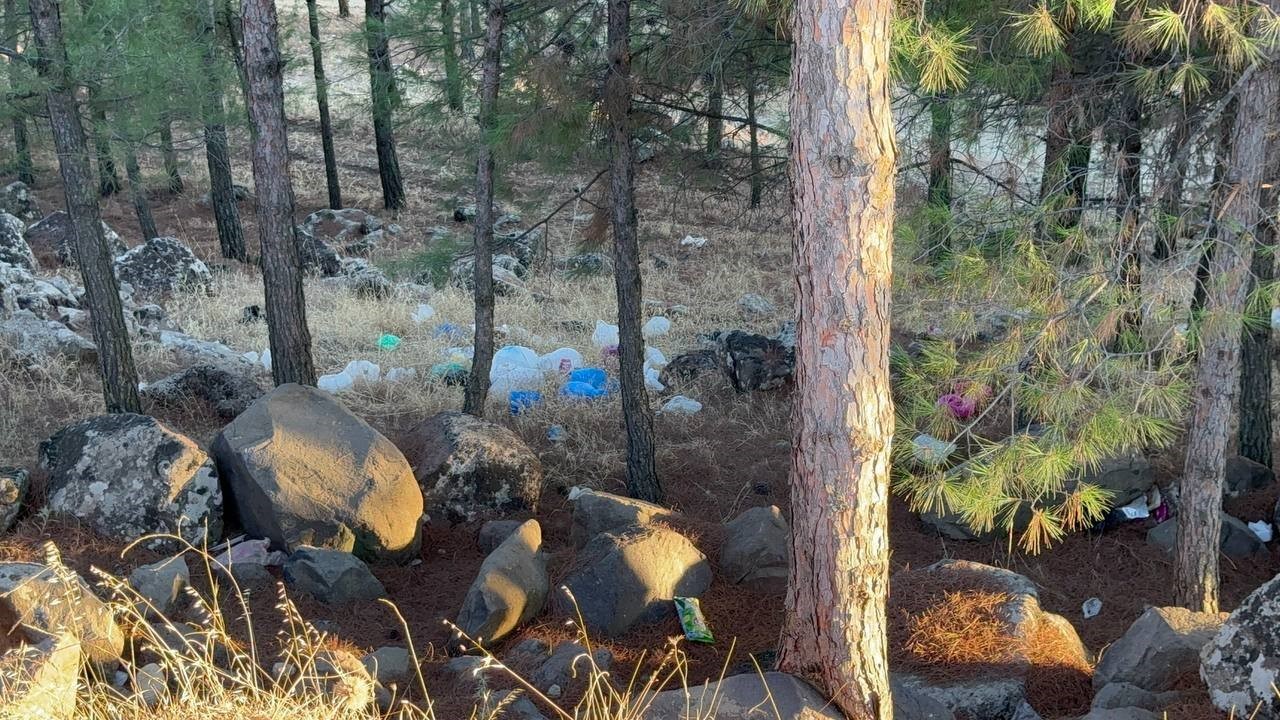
[141,363,264,420]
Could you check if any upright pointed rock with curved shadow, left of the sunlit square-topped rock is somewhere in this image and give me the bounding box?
[456,520,550,646]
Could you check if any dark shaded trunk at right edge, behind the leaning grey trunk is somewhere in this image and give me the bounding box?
[1238,138,1280,468]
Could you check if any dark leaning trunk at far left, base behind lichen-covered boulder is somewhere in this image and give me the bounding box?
[28,0,142,413]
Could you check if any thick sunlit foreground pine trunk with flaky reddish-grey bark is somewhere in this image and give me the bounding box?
[778,0,896,720]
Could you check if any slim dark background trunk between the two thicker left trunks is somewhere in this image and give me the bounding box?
[200,0,248,263]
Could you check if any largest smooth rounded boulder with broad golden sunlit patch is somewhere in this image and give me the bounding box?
[211,383,422,561]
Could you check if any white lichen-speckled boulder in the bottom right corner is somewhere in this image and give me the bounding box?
[1199,575,1280,720]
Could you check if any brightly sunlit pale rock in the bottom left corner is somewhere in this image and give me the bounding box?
[0,634,81,720]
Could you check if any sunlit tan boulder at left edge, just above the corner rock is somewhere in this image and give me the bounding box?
[0,559,124,665]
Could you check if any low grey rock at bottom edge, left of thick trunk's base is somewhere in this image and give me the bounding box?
[644,673,844,720]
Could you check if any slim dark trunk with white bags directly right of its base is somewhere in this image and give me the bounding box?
[462,0,507,418]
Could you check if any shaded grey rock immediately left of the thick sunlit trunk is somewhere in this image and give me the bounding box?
[719,505,791,589]
